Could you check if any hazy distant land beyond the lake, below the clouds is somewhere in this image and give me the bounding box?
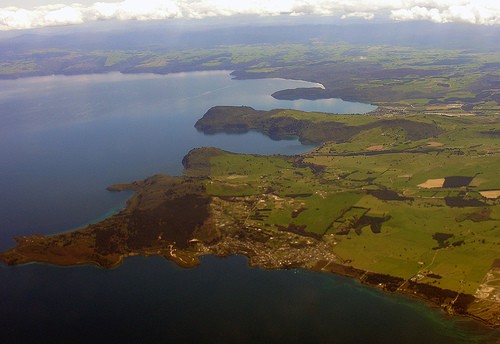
[0,22,500,113]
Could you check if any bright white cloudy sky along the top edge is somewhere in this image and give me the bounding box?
[0,0,500,31]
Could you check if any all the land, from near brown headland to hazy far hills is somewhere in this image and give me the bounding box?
[0,23,500,327]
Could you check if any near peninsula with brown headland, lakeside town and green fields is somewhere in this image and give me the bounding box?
[0,105,500,327]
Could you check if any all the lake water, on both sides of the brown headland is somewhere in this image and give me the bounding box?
[0,71,498,343]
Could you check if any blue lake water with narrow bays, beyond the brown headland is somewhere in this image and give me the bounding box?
[0,71,375,245]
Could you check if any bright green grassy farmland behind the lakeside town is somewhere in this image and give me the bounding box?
[200,111,500,294]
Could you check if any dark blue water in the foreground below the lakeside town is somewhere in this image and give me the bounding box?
[0,256,492,343]
